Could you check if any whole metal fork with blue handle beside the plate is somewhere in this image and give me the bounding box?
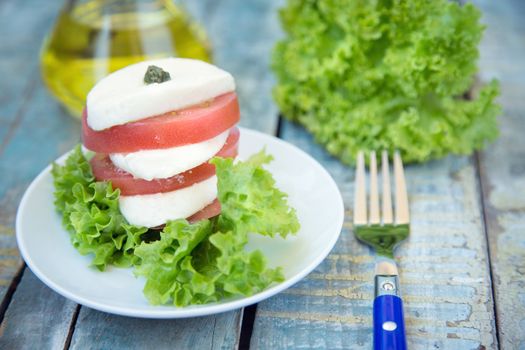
[354,151,410,350]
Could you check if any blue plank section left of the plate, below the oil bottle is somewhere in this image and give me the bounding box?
[0,78,79,308]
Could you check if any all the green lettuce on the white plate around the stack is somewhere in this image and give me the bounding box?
[52,146,299,306]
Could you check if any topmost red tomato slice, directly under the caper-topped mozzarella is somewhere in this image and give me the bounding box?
[82,92,240,153]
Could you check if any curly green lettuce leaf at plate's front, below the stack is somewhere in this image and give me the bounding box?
[135,219,283,306]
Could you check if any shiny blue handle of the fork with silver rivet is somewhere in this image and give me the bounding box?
[374,295,407,350]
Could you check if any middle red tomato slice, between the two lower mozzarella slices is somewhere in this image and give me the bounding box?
[90,128,239,196]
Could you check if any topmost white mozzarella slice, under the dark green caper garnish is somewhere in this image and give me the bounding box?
[86,58,235,130]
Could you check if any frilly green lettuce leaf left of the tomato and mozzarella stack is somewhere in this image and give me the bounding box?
[52,146,147,270]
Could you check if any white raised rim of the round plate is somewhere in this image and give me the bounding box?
[15,127,344,319]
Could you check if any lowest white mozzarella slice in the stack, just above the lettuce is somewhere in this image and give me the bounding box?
[119,176,217,227]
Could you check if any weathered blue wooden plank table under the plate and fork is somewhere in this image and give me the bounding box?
[0,0,525,349]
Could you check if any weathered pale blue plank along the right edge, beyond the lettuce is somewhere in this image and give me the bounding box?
[476,0,525,350]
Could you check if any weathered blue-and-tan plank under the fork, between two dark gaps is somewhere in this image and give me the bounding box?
[251,122,497,349]
